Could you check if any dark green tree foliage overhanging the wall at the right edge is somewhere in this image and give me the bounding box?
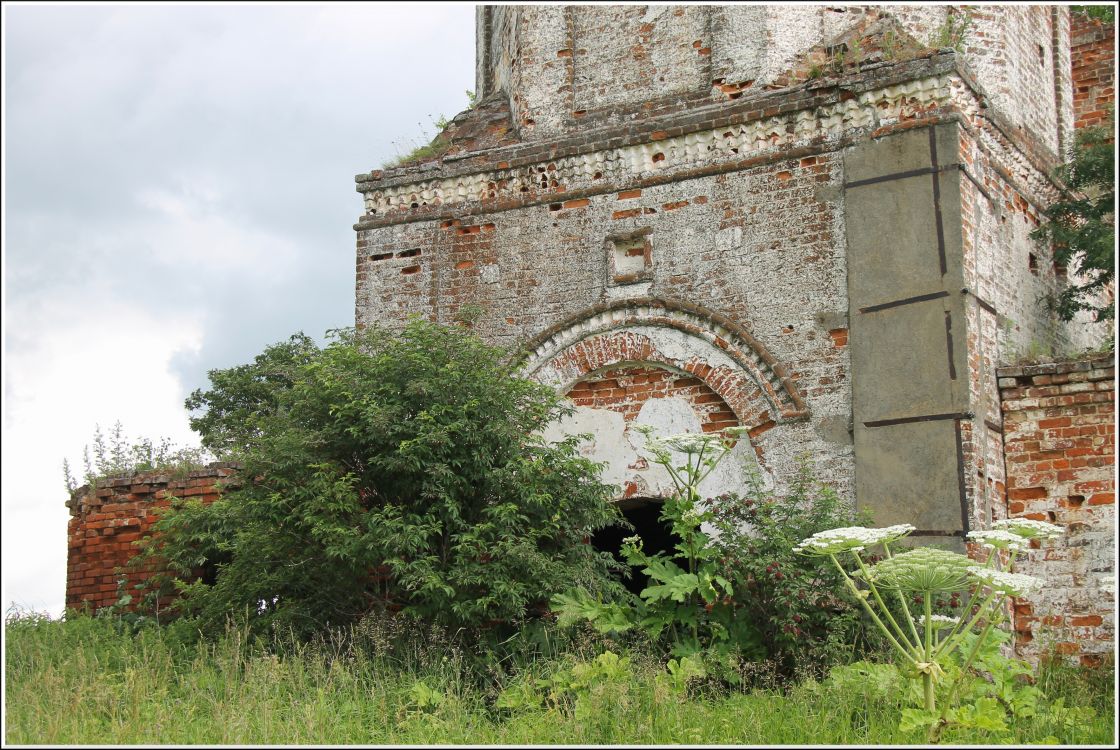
[1032,118,1116,329]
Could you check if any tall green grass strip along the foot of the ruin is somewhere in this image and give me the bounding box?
[4,617,1114,744]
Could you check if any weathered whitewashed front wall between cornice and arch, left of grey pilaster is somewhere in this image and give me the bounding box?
[358,138,851,501]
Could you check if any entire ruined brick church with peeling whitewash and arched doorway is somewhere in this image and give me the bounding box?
[67,6,1114,663]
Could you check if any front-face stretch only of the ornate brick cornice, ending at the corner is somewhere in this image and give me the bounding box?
[355,54,955,229]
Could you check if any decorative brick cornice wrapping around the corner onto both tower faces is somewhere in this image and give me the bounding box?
[354,50,1070,231]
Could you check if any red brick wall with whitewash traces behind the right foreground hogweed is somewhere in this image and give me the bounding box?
[998,358,1116,664]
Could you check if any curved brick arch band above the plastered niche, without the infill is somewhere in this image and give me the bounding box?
[521,299,809,430]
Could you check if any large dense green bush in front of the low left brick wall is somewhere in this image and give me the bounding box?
[144,320,617,635]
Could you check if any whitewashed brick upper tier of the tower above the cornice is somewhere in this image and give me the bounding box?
[468,6,1070,151]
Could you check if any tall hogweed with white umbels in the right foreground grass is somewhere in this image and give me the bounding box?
[795,518,1062,740]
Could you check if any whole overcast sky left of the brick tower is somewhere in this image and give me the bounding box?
[2,2,474,616]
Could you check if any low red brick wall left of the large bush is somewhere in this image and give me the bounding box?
[66,463,236,611]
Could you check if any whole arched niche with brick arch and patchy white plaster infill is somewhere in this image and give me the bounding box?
[521,299,808,498]
